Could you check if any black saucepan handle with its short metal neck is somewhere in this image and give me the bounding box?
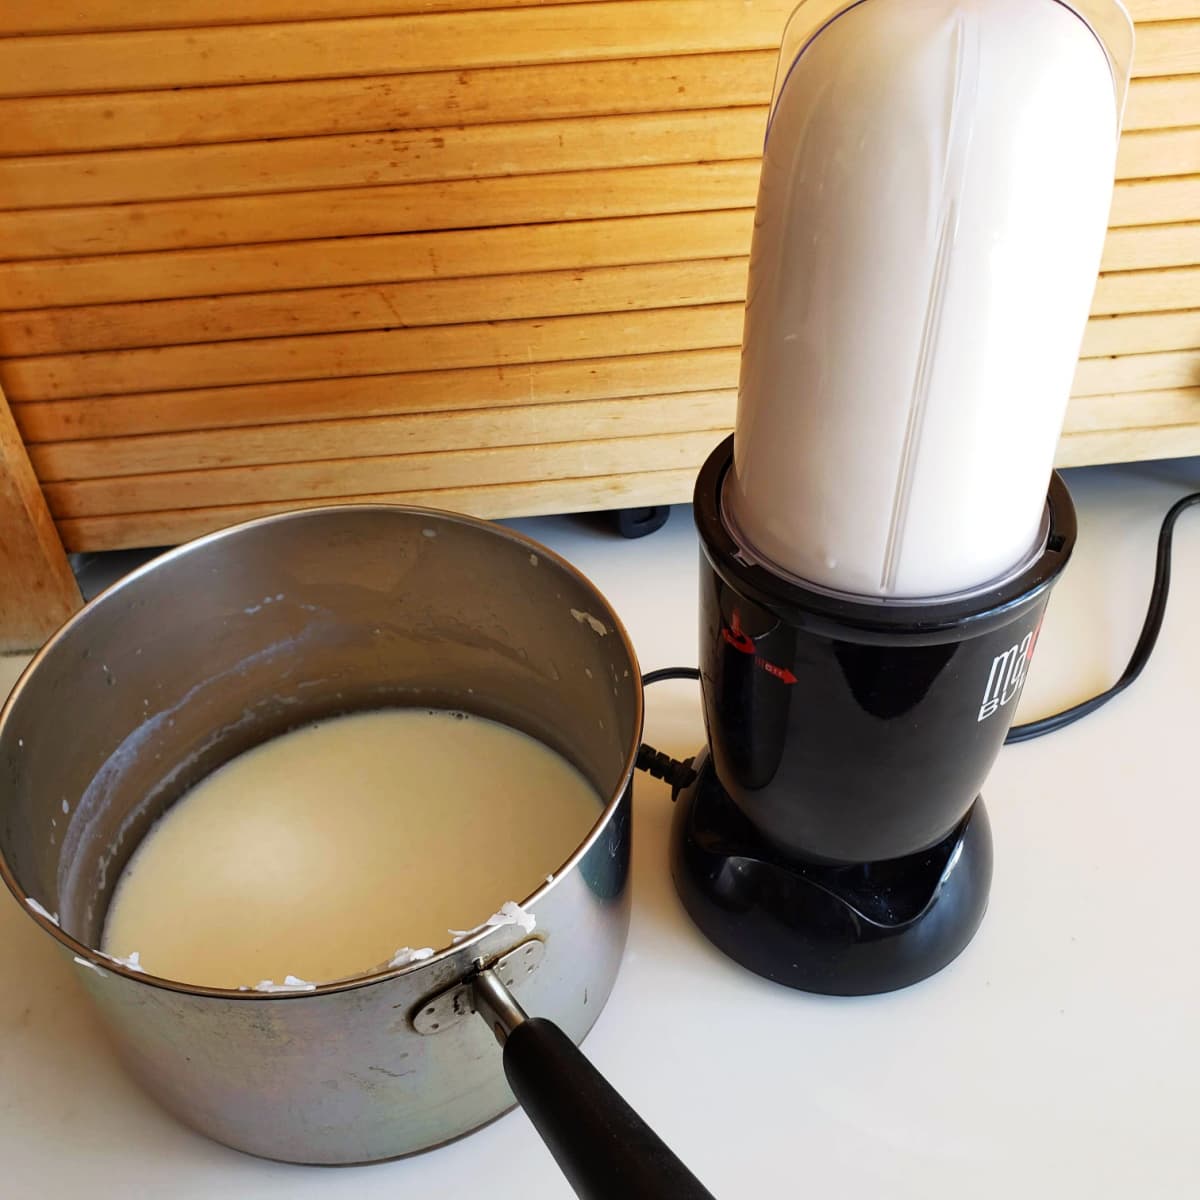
[474,971,714,1200]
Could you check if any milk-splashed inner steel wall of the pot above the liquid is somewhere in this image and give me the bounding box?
[0,505,642,948]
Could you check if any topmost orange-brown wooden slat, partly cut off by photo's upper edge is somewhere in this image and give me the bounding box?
[0,0,600,36]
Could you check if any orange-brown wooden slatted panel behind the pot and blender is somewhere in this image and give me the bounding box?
[0,0,1200,641]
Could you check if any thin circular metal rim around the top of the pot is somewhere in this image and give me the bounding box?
[0,503,646,1002]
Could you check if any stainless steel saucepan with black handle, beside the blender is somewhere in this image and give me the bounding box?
[0,505,707,1195]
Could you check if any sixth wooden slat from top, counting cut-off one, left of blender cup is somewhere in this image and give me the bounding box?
[0,209,748,311]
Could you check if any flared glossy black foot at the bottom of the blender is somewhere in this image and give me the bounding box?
[671,752,991,996]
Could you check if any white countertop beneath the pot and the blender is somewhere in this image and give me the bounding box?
[0,461,1200,1200]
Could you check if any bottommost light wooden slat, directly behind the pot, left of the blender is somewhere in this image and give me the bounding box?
[59,467,696,550]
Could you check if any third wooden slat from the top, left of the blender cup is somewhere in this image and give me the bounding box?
[0,51,768,155]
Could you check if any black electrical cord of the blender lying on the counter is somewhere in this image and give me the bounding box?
[637,492,1200,777]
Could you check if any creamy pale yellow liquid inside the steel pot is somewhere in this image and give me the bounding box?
[103,709,602,988]
